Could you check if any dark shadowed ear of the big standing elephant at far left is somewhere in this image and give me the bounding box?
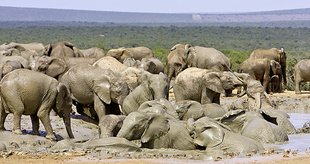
[55,83,72,117]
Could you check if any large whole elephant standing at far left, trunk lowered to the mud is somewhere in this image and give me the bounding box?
[0,69,74,139]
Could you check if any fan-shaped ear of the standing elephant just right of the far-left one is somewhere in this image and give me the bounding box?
[93,77,112,104]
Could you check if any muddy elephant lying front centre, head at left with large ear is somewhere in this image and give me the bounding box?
[117,112,196,150]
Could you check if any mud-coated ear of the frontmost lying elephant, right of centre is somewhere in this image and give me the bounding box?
[194,121,225,148]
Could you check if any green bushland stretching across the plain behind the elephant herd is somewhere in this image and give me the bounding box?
[0,25,310,90]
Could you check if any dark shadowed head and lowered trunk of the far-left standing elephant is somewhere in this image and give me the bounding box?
[54,83,74,138]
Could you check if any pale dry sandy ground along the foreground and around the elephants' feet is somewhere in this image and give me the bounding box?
[0,92,310,164]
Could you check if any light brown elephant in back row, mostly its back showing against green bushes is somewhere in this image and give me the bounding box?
[107,46,154,63]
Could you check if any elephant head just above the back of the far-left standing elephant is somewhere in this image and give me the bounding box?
[29,56,67,79]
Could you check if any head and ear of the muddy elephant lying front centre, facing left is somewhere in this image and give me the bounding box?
[117,112,149,140]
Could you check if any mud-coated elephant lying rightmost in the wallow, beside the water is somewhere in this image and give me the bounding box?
[219,109,289,143]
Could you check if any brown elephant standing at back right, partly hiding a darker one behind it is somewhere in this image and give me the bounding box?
[238,58,282,93]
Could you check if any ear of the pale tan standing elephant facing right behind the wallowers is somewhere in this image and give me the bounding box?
[203,72,225,94]
